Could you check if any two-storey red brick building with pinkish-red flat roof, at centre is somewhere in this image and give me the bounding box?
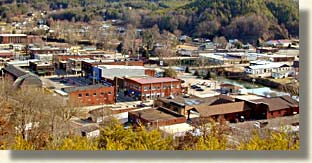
[124,77,182,100]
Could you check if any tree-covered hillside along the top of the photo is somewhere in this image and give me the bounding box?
[0,0,299,41]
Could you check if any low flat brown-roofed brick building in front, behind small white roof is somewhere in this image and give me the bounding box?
[128,107,186,128]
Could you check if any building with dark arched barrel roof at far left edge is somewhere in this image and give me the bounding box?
[2,65,42,87]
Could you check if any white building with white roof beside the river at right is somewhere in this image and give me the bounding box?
[245,62,293,77]
